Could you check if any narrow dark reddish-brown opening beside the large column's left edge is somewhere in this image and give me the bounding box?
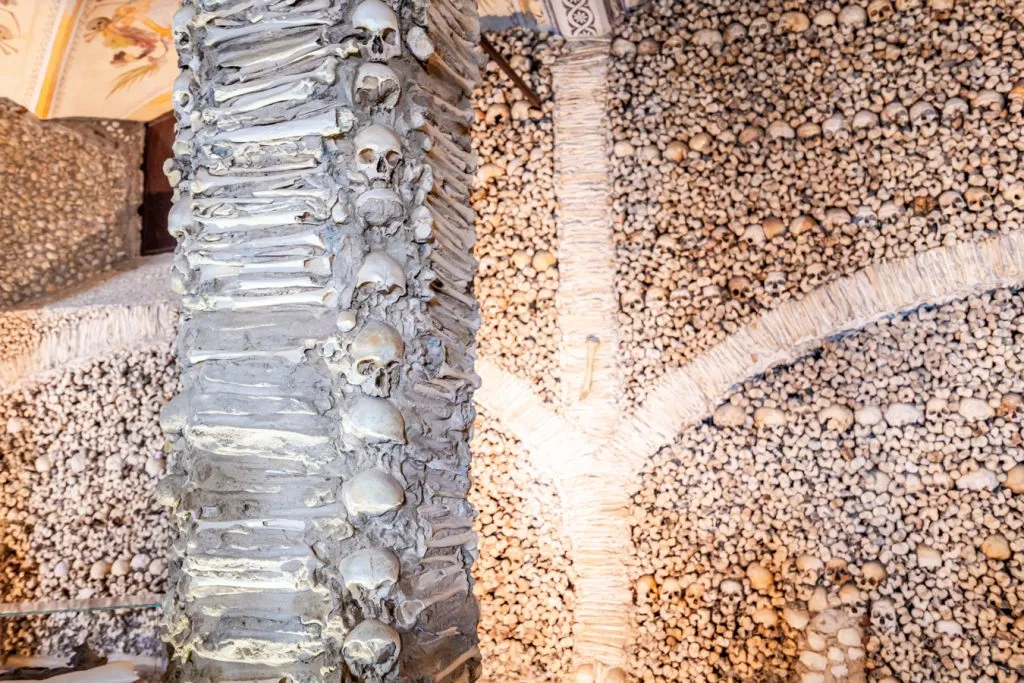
[142,112,175,256]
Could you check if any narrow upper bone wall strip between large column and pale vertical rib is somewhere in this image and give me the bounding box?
[472,29,562,400]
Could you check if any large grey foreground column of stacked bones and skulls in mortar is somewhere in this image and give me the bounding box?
[162,0,479,683]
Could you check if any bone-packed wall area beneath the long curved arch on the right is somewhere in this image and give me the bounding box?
[631,290,1024,682]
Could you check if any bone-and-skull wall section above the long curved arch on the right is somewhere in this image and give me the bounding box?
[609,0,1024,399]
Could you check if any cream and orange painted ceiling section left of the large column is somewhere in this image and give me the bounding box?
[0,0,180,121]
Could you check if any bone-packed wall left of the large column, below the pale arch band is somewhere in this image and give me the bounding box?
[0,350,178,654]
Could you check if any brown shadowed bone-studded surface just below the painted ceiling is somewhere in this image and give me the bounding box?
[0,100,144,307]
